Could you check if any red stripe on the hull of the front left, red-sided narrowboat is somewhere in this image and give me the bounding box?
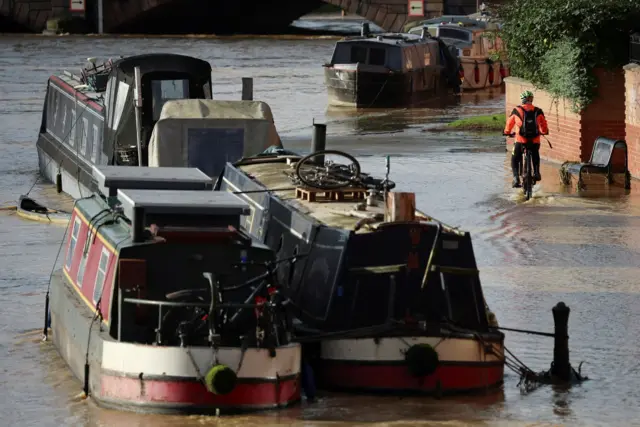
[99,375,300,410]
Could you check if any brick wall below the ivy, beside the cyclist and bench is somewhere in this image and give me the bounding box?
[505,69,624,166]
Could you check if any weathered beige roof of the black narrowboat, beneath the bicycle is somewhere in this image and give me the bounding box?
[239,156,424,233]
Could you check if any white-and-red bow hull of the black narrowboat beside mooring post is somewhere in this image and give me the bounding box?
[317,336,504,394]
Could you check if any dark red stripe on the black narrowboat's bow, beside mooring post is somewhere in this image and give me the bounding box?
[318,361,504,393]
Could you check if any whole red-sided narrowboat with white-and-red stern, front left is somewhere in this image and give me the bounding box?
[45,166,301,414]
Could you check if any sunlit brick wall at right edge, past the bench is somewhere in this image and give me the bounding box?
[624,64,640,178]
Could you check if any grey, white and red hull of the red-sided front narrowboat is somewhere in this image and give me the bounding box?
[50,274,300,414]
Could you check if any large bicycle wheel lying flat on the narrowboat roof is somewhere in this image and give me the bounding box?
[296,150,360,190]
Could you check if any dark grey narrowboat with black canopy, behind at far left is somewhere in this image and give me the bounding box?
[36,53,212,199]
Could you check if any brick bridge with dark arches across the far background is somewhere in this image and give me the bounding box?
[0,0,476,34]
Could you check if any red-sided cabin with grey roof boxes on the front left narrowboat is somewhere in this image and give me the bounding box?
[63,166,275,345]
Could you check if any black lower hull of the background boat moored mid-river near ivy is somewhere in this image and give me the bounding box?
[324,67,447,108]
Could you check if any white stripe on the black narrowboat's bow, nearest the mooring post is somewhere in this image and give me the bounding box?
[320,337,504,362]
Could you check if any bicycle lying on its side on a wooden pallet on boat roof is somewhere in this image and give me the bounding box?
[294,150,396,191]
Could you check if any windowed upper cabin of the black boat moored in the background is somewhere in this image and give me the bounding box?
[326,33,441,72]
